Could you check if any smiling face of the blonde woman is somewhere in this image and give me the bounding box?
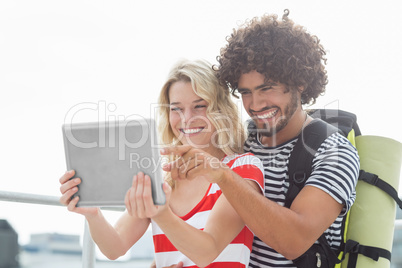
[169,81,216,150]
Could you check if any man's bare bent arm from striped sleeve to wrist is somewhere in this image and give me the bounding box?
[217,170,343,260]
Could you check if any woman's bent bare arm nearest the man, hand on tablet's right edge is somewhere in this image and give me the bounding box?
[129,174,261,267]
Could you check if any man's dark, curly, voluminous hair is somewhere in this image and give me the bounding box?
[214,9,328,104]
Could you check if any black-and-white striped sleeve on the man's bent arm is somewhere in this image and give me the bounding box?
[306,133,360,215]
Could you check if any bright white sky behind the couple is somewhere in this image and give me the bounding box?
[0,0,402,246]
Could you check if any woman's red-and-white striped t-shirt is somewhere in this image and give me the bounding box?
[152,153,264,268]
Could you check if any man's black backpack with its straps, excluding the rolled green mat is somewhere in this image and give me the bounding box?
[285,109,402,268]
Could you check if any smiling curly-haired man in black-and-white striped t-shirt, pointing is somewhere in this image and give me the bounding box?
[164,11,359,267]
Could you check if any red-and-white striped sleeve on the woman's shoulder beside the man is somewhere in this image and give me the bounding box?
[229,153,265,194]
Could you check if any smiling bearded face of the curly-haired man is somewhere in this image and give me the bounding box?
[238,71,300,137]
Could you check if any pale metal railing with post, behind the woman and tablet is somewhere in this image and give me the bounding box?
[0,188,402,268]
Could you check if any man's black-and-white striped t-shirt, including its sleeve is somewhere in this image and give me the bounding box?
[244,129,360,267]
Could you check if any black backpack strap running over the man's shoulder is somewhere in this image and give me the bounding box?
[285,119,338,208]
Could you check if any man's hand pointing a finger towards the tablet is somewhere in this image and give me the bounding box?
[161,145,230,183]
